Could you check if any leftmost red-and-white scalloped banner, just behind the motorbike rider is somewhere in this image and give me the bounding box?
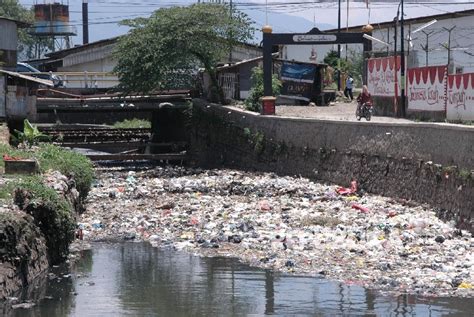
[367,56,401,97]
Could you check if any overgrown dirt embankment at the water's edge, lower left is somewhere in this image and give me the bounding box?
[0,172,79,299]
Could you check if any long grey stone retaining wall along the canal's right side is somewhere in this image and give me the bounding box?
[190,101,474,230]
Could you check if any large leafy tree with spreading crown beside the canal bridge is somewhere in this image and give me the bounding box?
[115,3,254,101]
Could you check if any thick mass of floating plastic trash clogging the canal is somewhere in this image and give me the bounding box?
[78,167,474,297]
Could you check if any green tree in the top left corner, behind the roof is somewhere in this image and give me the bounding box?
[0,0,34,56]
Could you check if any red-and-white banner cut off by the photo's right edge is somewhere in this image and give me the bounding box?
[446,74,474,121]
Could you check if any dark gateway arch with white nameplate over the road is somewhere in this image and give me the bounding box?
[262,25,372,115]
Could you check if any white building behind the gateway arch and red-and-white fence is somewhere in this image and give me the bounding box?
[281,10,474,73]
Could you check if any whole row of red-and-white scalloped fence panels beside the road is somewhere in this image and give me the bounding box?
[367,56,474,121]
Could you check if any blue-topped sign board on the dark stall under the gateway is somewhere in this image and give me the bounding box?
[281,62,317,99]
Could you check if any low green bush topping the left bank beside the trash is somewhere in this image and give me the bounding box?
[35,144,94,199]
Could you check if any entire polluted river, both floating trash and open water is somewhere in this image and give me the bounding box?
[4,167,474,316]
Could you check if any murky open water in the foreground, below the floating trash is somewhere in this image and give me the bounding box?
[1,243,474,317]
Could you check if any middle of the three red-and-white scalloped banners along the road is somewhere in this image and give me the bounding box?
[407,66,448,111]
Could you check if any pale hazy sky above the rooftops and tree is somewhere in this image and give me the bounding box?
[20,0,474,44]
